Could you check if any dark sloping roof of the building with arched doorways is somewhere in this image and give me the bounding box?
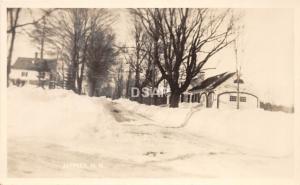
[188,72,235,92]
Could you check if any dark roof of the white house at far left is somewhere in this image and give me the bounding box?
[12,57,57,72]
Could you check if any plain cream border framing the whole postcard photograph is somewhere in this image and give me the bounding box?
[0,0,300,185]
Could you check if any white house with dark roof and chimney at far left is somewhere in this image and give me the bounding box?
[10,53,58,88]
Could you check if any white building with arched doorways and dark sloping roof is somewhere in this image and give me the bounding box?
[181,72,259,109]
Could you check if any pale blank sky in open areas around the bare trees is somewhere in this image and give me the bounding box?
[13,9,294,105]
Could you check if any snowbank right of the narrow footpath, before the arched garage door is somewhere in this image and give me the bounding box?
[186,109,294,156]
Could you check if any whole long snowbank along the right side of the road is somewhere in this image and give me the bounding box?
[115,99,294,156]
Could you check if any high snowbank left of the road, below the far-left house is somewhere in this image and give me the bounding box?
[8,86,113,143]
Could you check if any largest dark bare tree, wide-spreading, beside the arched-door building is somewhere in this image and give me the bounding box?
[131,8,234,107]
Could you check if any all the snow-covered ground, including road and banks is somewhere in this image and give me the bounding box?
[8,87,293,178]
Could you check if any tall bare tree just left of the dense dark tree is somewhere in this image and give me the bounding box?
[46,9,113,94]
